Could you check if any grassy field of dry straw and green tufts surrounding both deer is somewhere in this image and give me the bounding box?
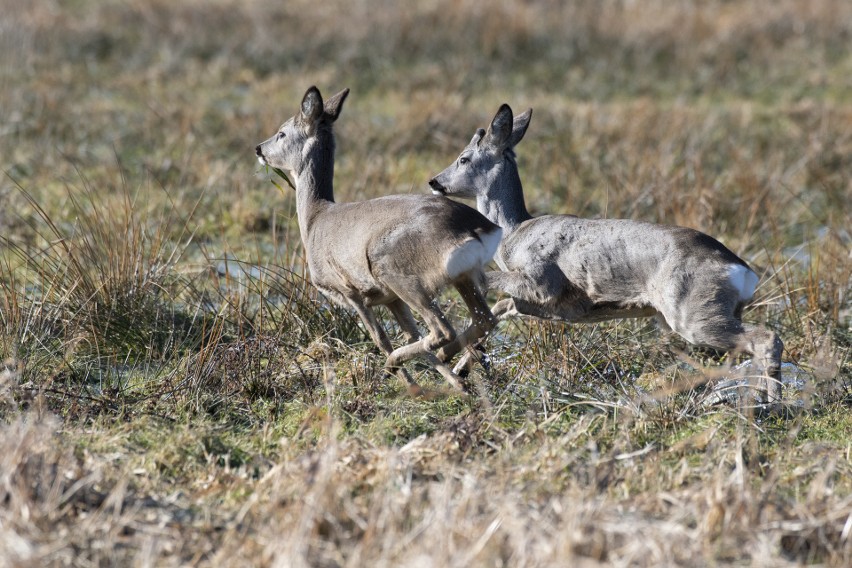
[0,0,852,567]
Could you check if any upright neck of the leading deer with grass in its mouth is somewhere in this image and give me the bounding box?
[296,138,334,237]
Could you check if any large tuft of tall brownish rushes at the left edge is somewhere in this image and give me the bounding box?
[0,176,210,404]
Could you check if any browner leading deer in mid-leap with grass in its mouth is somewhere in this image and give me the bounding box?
[255,86,502,390]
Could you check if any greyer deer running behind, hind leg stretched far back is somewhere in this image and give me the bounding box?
[429,104,783,407]
